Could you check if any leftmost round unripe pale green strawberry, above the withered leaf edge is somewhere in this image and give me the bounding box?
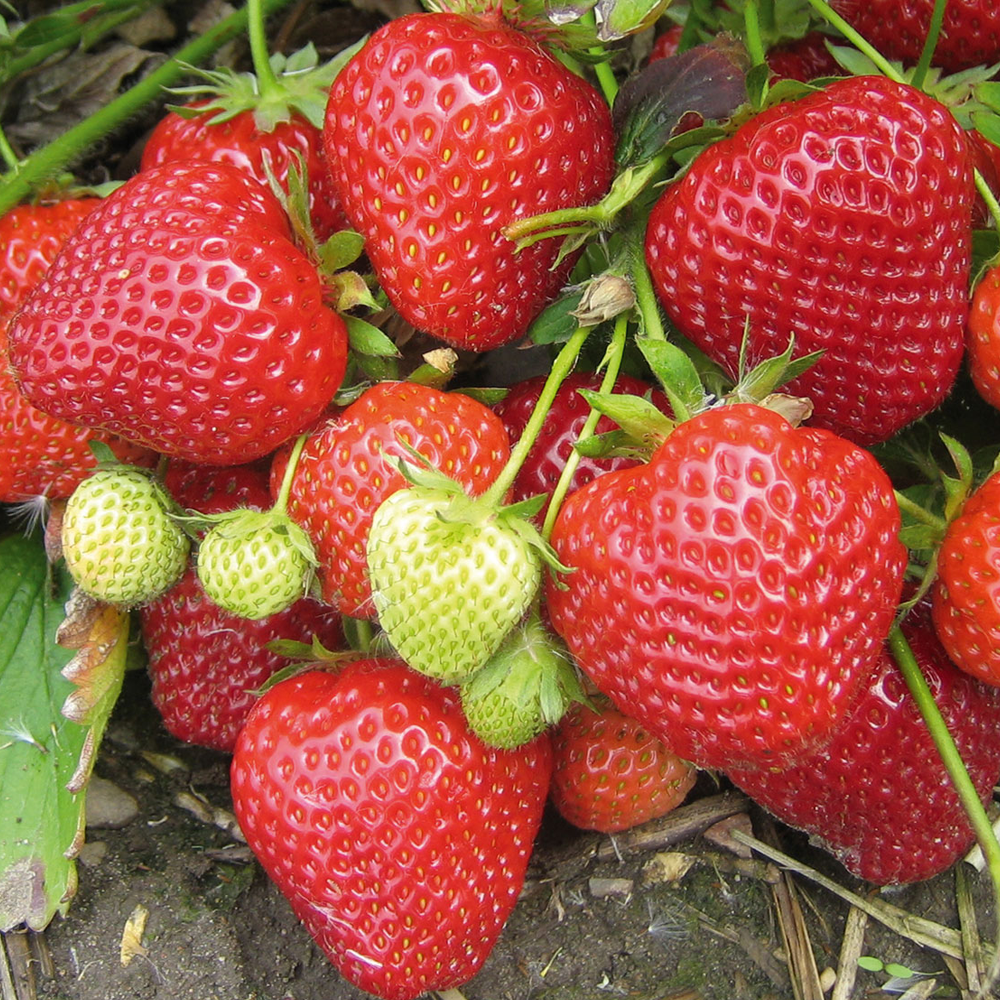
[62,466,190,605]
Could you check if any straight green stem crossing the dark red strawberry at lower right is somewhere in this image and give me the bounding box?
[889,624,1000,995]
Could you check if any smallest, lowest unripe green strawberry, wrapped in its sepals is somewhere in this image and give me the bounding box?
[460,617,584,750]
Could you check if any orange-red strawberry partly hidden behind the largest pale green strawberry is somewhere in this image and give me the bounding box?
[271,382,510,618]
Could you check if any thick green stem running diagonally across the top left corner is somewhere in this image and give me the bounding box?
[0,0,290,215]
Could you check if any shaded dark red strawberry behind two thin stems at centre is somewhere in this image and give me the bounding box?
[493,372,670,510]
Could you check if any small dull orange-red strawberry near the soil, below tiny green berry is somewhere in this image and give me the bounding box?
[550,698,698,833]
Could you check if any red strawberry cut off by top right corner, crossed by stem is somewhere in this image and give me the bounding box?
[830,0,1000,73]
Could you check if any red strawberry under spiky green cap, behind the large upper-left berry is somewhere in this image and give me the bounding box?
[140,101,349,240]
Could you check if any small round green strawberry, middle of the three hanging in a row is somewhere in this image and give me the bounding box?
[197,509,316,620]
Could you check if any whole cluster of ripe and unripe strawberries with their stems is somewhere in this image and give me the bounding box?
[0,0,1000,1000]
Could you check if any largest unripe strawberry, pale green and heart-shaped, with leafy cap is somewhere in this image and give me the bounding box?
[368,484,542,683]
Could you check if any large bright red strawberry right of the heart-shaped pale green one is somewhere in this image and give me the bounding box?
[546,403,907,768]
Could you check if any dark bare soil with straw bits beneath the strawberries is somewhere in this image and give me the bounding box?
[0,671,993,1000]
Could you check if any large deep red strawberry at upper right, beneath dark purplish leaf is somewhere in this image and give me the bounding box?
[646,77,973,444]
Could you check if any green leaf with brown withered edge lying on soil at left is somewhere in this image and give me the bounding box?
[0,535,127,931]
